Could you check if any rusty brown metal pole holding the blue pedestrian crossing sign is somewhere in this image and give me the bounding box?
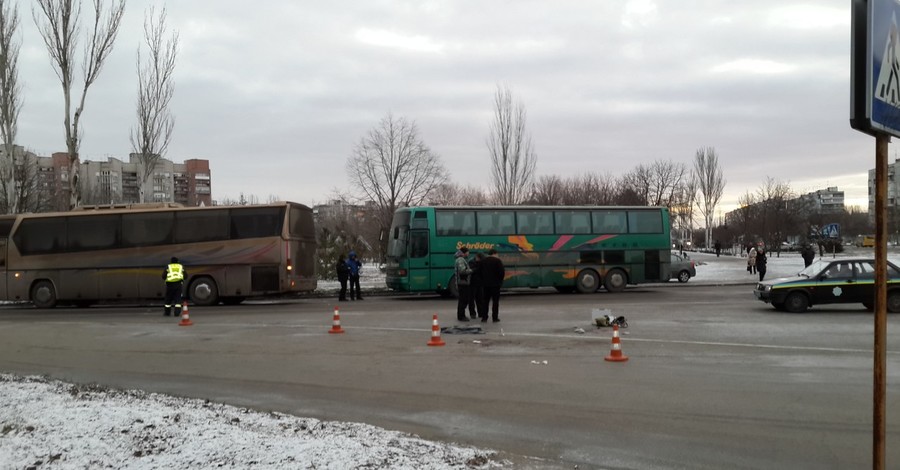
[872,134,891,470]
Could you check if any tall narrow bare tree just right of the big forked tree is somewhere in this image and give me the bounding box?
[131,6,178,202]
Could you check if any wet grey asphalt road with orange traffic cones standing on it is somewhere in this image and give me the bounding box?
[0,283,900,469]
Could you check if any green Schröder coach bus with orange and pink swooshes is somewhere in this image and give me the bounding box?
[386,206,672,295]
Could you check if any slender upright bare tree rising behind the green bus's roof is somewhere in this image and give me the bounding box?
[487,85,537,205]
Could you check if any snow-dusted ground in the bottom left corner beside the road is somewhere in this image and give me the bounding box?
[0,374,508,470]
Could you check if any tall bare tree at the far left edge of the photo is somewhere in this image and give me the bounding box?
[0,0,23,214]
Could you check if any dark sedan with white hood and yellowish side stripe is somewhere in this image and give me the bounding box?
[753,258,900,312]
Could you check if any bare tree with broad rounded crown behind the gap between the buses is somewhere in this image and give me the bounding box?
[347,113,447,248]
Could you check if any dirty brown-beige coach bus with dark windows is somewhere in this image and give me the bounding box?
[0,202,316,308]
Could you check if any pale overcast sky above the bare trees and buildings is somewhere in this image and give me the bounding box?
[10,0,876,208]
